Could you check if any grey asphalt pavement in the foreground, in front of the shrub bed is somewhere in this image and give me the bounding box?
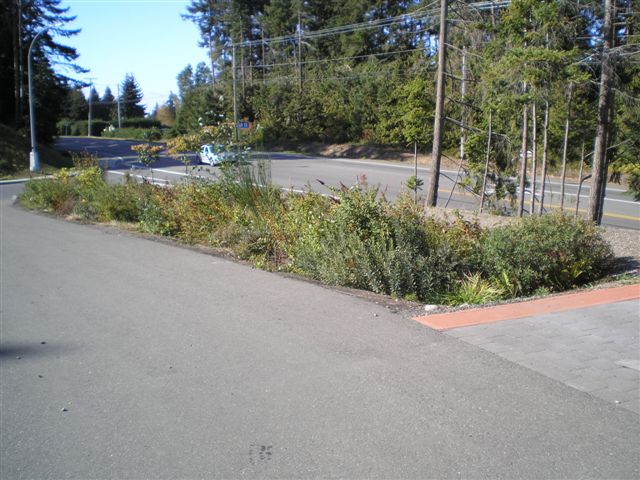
[0,185,640,479]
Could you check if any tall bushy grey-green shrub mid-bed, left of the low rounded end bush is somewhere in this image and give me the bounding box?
[294,185,460,300]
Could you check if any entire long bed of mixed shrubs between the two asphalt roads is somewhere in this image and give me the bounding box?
[21,162,613,305]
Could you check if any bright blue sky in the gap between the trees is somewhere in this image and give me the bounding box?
[57,0,208,113]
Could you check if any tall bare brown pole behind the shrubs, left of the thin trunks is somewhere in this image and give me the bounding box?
[426,0,448,207]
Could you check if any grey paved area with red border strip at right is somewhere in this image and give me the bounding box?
[415,285,640,415]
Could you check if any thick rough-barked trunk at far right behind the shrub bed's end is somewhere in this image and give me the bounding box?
[588,0,614,225]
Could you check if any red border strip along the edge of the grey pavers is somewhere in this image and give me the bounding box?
[413,285,640,330]
